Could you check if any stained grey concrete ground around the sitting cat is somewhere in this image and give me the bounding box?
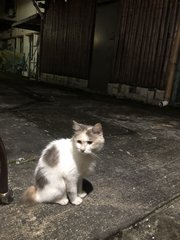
[0,74,180,240]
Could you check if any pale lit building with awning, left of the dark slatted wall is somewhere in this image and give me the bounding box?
[0,0,40,78]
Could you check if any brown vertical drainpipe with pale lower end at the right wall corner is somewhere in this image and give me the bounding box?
[159,19,180,107]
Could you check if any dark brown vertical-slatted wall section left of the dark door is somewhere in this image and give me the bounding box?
[41,0,96,79]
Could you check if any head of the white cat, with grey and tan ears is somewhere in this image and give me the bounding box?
[73,121,105,154]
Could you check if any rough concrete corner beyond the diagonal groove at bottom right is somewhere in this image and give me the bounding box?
[118,196,180,240]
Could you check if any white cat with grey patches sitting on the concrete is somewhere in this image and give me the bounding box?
[23,121,105,205]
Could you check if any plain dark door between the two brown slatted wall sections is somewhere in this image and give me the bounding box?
[89,1,119,93]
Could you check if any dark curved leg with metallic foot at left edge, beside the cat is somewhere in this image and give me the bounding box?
[0,138,13,204]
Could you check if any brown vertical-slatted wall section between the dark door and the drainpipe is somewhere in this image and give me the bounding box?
[111,0,180,90]
